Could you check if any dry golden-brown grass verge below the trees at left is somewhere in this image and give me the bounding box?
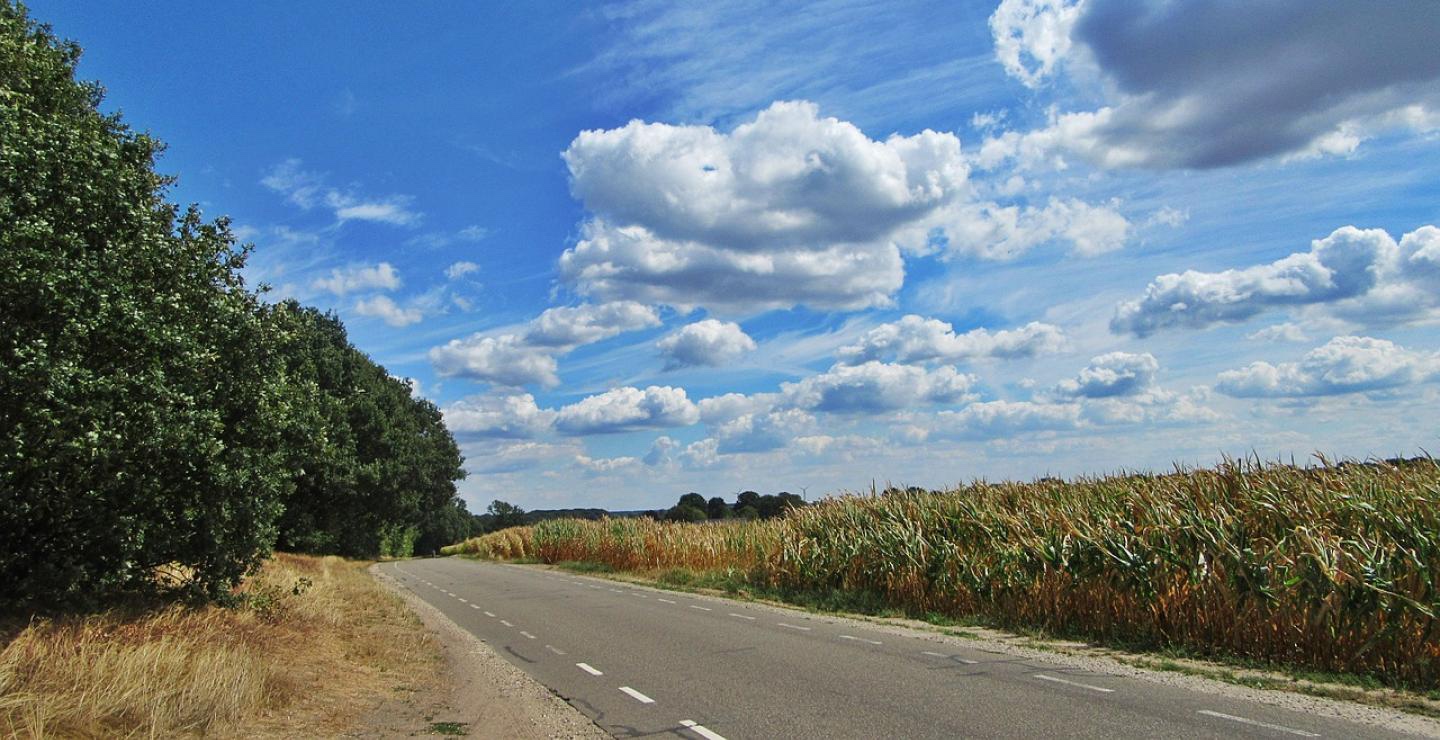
[0,554,439,739]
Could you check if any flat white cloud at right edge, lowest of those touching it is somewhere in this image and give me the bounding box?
[1215,337,1440,399]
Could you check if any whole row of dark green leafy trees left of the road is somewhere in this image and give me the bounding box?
[0,0,471,608]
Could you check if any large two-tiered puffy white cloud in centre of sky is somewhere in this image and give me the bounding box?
[560,102,968,312]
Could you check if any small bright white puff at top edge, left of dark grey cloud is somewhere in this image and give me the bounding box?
[989,0,1080,88]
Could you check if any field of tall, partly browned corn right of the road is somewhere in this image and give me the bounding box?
[448,459,1440,688]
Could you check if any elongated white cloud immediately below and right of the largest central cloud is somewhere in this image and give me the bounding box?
[837,314,1064,364]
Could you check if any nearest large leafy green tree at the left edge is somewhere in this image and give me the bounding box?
[0,1,295,606]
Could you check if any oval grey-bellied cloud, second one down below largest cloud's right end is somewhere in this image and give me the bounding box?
[780,361,975,413]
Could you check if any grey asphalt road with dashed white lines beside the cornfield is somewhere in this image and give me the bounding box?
[383,559,1428,740]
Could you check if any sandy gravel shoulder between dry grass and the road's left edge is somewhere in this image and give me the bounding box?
[365,566,609,739]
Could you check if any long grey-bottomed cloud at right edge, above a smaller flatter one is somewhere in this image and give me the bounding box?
[1110,226,1440,337]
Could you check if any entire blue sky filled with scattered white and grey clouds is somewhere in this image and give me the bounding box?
[32,0,1440,511]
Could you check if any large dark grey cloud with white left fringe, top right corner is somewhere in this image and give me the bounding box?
[982,0,1440,168]
